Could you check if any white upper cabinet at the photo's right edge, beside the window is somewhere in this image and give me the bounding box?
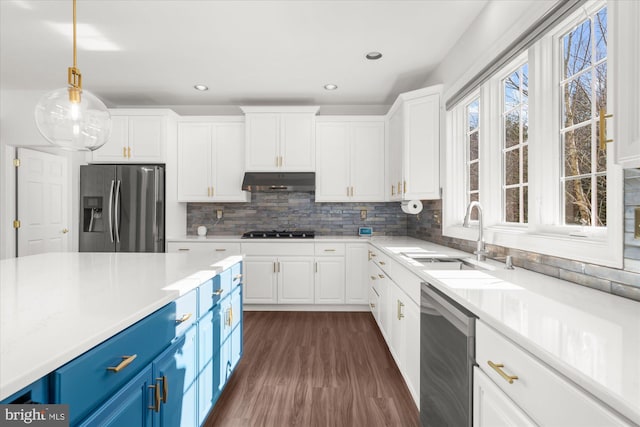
[607,1,640,168]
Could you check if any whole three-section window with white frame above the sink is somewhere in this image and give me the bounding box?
[442,0,624,268]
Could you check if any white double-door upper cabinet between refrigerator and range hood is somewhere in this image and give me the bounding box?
[178,117,249,202]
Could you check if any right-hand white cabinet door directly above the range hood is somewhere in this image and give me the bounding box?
[280,114,315,172]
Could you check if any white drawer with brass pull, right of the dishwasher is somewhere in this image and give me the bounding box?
[476,322,629,427]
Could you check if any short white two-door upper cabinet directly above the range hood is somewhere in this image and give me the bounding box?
[241,107,318,172]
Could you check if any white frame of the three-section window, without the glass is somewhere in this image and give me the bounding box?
[442,0,624,268]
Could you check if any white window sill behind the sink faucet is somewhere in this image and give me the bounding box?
[442,224,623,268]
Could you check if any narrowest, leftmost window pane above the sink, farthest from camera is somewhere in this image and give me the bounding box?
[465,98,480,220]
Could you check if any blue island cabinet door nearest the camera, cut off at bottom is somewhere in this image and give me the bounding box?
[80,365,155,427]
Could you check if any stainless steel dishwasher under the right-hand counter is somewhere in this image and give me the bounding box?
[420,282,476,427]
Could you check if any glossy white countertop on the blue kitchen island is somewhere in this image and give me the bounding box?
[0,253,241,400]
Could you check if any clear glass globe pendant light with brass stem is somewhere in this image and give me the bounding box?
[35,0,111,151]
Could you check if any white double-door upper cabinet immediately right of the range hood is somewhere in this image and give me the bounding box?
[316,117,385,202]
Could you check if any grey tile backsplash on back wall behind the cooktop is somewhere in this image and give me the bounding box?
[187,192,407,236]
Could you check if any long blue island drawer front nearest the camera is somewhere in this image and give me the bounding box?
[51,303,176,425]
